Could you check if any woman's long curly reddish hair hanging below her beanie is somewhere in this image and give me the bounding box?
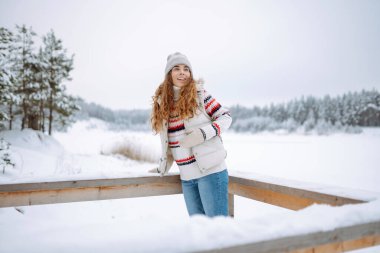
[150,71,199,134]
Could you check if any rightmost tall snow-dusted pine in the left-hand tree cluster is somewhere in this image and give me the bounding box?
[43,30,74,135]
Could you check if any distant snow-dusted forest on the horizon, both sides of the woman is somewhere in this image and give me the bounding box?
[74,89,380,134]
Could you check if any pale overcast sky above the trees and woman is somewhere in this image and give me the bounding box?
[0,0,380,109]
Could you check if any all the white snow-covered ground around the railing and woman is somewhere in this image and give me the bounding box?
[0,120,380,252]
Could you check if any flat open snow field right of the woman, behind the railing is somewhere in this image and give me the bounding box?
[223,129,380,192]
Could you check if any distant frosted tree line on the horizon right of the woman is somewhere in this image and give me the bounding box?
[230,89,380,134]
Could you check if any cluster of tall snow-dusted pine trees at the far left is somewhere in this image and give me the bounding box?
[0,25,80,135]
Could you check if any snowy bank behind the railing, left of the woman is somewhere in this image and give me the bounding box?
[0,120,158,184]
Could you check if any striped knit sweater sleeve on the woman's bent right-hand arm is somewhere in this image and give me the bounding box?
[201,90,232,140]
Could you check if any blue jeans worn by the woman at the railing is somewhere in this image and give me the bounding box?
[181,169,228,217]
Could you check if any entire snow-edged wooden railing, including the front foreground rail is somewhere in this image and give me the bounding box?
[0,175,380,253]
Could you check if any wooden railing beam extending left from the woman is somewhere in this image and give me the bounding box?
[0,175,182,207]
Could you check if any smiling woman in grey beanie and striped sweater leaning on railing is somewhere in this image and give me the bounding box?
[151,52,232,217]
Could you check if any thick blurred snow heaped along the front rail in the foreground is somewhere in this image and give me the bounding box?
[0,200,380,252]
